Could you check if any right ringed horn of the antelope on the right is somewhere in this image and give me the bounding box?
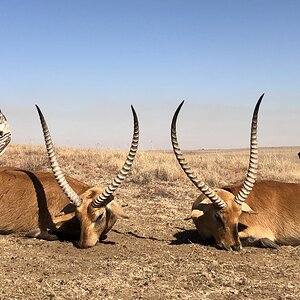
[234,94,264,205]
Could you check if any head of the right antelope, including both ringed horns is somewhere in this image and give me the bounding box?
[171,95,264,250]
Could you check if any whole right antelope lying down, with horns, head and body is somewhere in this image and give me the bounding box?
[171,95,300,250]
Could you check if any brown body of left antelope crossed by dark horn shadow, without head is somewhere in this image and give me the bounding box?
[0,167,90,237]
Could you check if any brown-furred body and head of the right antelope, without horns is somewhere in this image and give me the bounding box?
[192,181,300,249]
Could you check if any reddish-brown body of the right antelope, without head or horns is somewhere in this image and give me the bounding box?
[224,180,300,245]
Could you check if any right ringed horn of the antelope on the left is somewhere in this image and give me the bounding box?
[91,105,139,208]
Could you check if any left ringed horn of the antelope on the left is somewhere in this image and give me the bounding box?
[35,105,82,207]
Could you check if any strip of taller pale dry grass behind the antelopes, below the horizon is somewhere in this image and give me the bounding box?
[0,145,300,187]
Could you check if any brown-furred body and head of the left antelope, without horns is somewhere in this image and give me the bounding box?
[0,167,124,248]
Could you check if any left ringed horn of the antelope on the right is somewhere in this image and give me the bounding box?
[171,101,226,208]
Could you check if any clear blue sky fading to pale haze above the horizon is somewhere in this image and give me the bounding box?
[0,0,300,150]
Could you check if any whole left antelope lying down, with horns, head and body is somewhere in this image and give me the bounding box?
[0,107,139,248]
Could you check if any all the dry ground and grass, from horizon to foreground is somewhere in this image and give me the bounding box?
[0,145,300,299]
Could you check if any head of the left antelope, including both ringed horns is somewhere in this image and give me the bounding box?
[36,105,139,248]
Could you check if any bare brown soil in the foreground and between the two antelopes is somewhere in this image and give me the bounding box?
[0,184,300,300]
